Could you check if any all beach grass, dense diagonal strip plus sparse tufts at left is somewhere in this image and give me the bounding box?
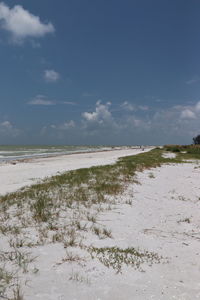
[0,146,200,296]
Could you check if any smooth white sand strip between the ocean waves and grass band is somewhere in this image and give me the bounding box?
[0,148,152,195]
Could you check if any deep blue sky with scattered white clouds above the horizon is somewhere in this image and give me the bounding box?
[0,0,200,145]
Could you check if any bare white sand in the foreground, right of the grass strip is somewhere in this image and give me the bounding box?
[0,152,200,300]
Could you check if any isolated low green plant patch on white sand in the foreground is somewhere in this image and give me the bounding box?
[88,247,162,273]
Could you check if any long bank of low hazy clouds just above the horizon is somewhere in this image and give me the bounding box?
[36,101,200,144]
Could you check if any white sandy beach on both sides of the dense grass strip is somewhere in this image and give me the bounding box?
[0,150,200,300]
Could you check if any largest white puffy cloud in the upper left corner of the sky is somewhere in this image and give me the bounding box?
[0,2,55,42]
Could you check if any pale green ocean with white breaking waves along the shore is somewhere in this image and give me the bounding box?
[0,146,112,162]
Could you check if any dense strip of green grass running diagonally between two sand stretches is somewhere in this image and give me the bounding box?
[0,146,197,232]
